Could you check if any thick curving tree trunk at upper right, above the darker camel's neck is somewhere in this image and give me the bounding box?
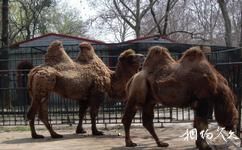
[218,0,232,46]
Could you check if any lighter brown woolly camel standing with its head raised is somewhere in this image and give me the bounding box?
[27,41,143,138]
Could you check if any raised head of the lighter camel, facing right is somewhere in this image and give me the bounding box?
[118,49,144,74]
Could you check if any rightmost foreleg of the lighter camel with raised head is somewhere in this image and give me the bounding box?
[90,92,104,135]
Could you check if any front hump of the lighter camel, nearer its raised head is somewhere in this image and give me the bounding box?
[77,42,96,62]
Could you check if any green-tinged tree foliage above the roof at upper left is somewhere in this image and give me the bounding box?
[9,0,86,45]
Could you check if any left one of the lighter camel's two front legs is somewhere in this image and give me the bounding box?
[76,100,88,134]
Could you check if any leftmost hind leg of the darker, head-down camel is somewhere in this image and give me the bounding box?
[122,101,137,147]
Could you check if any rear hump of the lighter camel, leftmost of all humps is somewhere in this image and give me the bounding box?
[46,40,65,56]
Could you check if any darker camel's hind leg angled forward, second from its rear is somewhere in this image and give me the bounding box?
[142,102,169,147]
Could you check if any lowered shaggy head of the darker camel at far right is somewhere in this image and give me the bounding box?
[214,84,239,130]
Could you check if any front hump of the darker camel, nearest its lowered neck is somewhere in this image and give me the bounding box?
[180,46,206,62]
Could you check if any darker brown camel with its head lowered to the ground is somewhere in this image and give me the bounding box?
[122,46,238,150]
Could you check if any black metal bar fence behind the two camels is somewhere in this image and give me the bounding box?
[0,43,242,137]
